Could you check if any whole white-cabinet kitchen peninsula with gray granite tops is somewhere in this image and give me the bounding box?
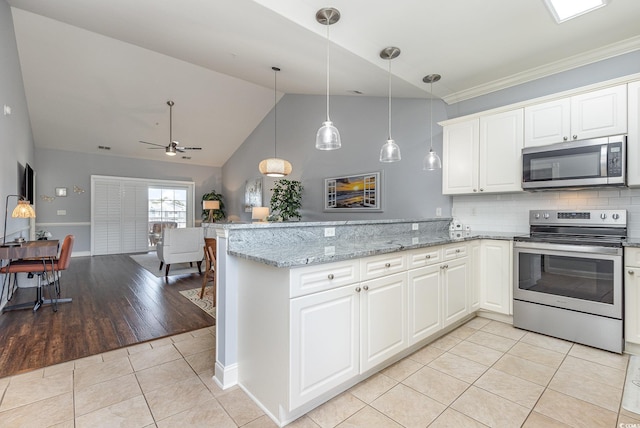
[203,218,511,426]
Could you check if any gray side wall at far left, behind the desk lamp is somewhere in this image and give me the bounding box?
[0,0,34,240]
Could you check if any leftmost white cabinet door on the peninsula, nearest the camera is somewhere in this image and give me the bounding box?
[290,285,360,409]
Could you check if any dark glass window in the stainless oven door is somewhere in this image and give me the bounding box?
[518,253,614,304]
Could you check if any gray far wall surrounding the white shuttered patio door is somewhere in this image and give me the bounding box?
[34,148,222,253]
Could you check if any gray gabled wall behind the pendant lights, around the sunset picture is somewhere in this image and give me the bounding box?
[222,95,451,221]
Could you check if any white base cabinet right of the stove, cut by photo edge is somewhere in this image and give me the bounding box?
[624,247,640,345]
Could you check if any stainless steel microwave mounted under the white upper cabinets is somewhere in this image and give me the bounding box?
[522,135,627,190]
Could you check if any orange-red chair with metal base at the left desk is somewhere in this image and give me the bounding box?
[0,235,75,312]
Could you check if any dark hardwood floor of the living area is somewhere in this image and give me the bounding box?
[0,255,215,377]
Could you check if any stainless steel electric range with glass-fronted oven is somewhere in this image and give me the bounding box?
[513,210,627,353]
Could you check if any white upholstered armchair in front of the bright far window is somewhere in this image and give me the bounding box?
[156,227,204,276]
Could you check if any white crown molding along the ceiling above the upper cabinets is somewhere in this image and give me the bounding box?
[442,36,640,104]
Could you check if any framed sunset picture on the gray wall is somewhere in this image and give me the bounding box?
[324,171,382,212]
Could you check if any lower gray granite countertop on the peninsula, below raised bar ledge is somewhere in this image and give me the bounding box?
[229,231,517,268]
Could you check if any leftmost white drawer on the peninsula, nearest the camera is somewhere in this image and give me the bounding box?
[289,260,360,298]
